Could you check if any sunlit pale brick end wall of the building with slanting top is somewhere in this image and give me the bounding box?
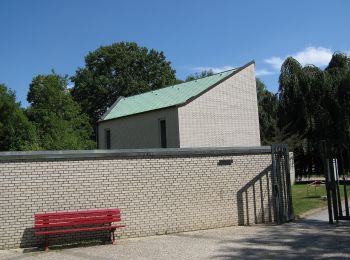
[178,64,260,147]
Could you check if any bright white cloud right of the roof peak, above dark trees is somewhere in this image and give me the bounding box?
[264,46,333,70]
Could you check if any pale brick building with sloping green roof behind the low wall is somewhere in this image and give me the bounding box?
[98,61,260,149]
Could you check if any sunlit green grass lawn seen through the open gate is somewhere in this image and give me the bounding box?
[292,184,350,216]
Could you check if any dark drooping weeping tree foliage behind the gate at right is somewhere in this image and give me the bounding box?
[277,53,350,178]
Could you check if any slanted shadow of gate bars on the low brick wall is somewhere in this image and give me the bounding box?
[237,166,274,225]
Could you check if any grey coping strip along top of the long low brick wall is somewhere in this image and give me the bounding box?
[0,146,271,161]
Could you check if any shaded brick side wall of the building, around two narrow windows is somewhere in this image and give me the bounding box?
[98,108,179,149]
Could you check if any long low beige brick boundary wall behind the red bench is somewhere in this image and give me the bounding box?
[0,149,273,249]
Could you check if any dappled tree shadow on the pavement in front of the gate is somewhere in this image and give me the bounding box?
[212,220,350,259]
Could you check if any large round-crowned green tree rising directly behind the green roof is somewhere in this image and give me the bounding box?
[72,42,176,126]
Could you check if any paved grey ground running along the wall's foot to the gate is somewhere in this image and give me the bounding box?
[0,211,350,260]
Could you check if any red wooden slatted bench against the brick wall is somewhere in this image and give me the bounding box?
[34,209,125,251]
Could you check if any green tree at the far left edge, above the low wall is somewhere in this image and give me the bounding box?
[0,84,39,151]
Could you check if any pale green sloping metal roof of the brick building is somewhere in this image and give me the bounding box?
[101,69,237,121]
